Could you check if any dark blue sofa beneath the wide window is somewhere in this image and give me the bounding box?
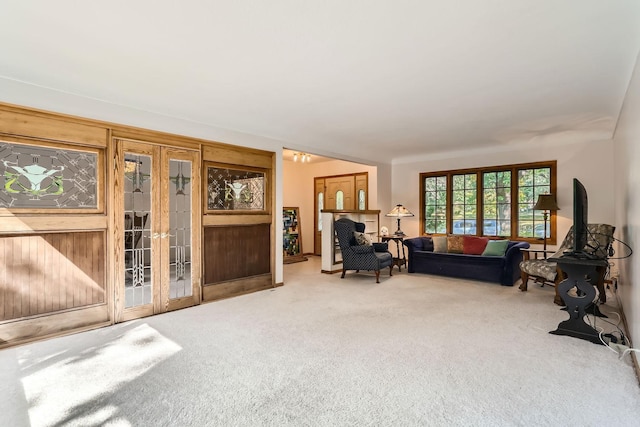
[403,237,529,286]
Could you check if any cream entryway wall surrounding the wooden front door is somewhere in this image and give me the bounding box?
[282,159,382,253]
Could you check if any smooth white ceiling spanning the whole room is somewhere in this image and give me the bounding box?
[0,0,640,162]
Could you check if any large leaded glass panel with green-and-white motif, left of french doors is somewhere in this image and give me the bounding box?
[0,142,98,209]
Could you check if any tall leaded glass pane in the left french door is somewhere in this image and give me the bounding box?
[124,153,153,308]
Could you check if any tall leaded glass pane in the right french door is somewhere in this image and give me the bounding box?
[169,160,193,298]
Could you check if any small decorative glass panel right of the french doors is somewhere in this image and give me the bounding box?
[207,166,265,211]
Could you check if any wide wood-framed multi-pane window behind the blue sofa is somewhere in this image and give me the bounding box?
[420,161,556,244]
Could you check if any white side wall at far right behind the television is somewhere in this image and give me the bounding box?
[614,51,640,347]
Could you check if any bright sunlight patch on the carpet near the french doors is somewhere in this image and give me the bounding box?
[20,324,182,427]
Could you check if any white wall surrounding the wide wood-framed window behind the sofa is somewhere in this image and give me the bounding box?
[392,136,615,252]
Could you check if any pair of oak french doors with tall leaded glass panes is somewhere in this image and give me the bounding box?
[114,140,201,322]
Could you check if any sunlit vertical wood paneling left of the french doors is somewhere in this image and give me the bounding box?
[0,232,106,322]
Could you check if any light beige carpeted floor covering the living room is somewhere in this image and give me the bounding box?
[0,257,640,426]
